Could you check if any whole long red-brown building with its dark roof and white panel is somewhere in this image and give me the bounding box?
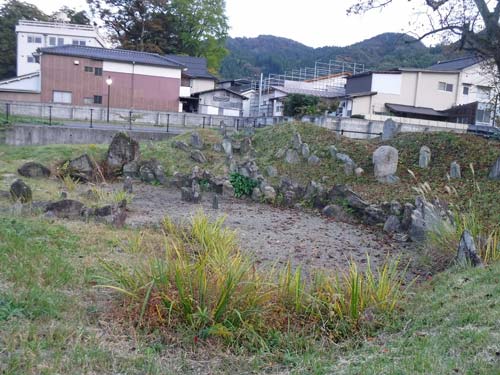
[40,45,185,112]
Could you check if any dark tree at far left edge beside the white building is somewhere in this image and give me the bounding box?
[0,0,49,79]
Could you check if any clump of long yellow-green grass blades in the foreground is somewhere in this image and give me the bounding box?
[101,213,404,347]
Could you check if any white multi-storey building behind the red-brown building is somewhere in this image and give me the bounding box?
[16,20,106,76]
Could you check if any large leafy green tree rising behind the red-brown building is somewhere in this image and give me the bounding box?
[87,0,228,72]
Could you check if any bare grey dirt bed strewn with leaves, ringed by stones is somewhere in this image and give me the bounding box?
[124,184,405,269]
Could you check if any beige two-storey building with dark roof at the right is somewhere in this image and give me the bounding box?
[341,57,496,124]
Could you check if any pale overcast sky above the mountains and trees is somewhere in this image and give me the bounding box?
[7,0,422,47]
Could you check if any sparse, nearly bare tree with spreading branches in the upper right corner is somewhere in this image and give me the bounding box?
[347,0,500,74]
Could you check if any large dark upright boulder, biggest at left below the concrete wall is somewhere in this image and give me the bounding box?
[106,133,140,174]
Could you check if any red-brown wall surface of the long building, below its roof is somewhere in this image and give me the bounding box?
[40,55,181,112]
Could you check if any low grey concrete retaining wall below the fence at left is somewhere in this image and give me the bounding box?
[4,125,175,146]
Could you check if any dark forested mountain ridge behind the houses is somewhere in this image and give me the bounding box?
[220,33,463,79]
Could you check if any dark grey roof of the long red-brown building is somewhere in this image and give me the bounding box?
[40,44,184,69]
